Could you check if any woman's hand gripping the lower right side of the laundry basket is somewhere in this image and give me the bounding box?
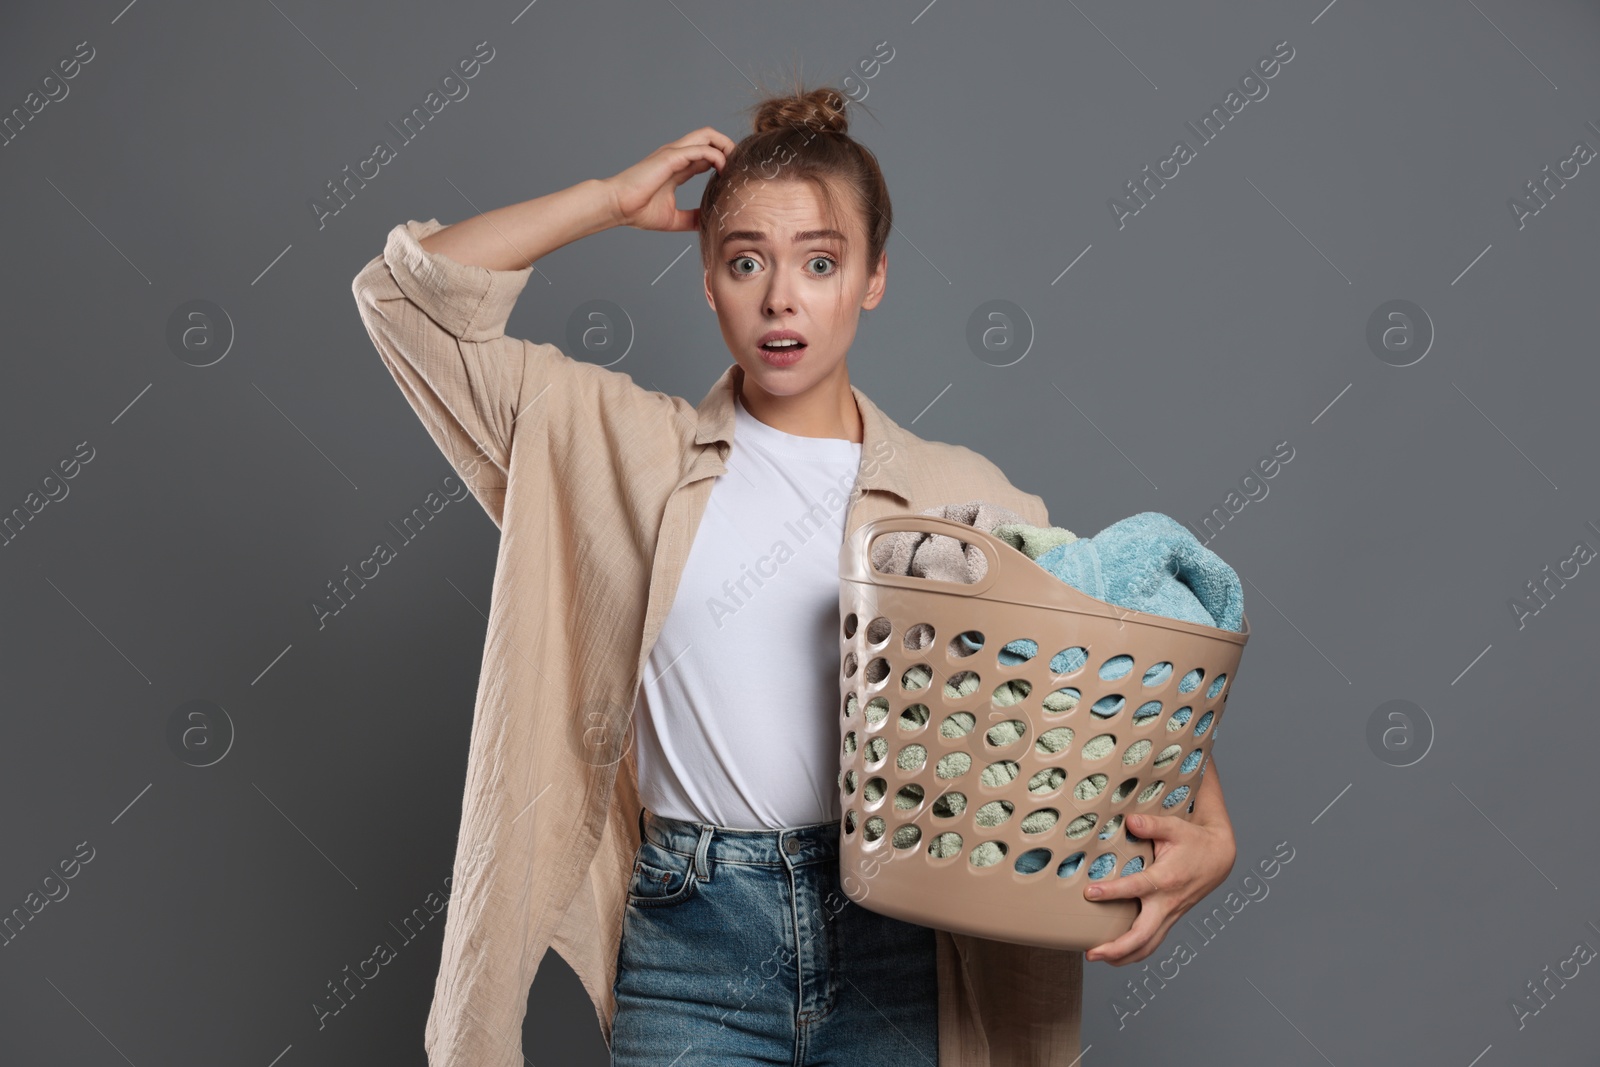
[1083,763,1237,966]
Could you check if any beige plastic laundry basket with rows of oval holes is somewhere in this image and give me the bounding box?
[838,514,1250,950]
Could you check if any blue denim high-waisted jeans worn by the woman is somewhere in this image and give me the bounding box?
[611,811,939,1067]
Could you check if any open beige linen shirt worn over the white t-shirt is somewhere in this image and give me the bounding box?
[350,219,1083,1067]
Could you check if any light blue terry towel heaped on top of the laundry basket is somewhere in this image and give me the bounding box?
[1000,512,1245,670]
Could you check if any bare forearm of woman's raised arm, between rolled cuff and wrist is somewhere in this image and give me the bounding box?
[421,178,621,270]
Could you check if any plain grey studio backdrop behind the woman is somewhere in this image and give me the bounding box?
[0,0,1600,1067]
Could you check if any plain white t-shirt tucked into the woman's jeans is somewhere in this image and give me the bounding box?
[634,388,861,830]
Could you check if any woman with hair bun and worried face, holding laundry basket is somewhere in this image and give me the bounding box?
[352,90,1234,1067]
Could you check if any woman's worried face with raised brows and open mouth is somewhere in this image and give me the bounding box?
[706,179,888,397]
